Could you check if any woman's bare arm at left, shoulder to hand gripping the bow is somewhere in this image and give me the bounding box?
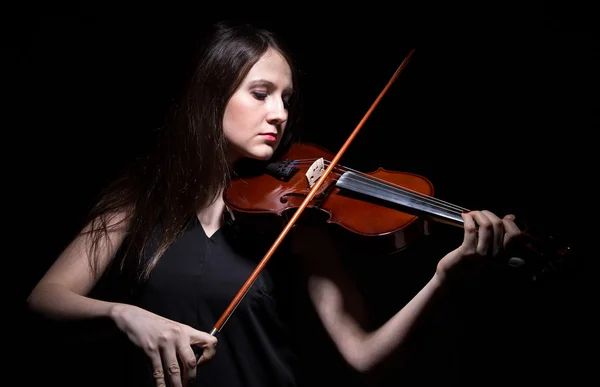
[27,215,217,387]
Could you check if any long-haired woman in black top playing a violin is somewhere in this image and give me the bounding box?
[28,25,519,387]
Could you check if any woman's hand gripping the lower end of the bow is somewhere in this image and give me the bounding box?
[111,304,217,387]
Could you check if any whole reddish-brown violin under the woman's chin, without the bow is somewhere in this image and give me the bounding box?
[224,143,575,281]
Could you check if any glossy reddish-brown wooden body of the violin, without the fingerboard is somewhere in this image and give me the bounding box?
[224,143,434,252]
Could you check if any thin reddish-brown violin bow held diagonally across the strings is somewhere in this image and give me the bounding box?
[210,49,415,336]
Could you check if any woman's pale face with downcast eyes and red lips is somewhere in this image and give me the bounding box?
[223,49,293,161]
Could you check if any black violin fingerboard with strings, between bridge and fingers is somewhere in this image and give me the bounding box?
[336,171,464,227]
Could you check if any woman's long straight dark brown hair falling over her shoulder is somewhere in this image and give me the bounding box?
[82,23,298,280]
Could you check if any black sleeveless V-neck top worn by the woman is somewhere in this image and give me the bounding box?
[119,218,297,387]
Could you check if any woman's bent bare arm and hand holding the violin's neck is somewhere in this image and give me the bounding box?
[294,211,519,372]
